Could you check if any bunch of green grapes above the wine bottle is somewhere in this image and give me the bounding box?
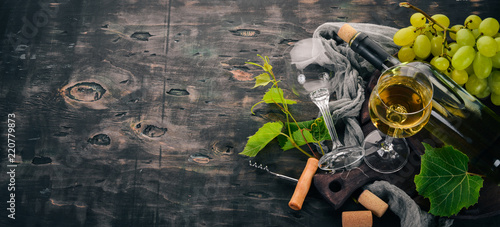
[393,13,500,105]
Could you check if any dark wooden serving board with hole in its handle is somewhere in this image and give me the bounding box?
[313,73,500,219]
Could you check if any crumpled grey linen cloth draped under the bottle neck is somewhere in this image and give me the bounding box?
[313,23,453,227]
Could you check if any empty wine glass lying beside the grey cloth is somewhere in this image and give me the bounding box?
[284,38,364,171]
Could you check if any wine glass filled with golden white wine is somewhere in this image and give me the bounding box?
[363,64,433,173]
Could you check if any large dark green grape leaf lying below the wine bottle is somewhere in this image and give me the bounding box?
[414,143,483,217]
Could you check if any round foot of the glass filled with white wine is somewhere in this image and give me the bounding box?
[363,130,410,173]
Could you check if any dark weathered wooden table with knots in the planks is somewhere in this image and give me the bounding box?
[0,0,500,226]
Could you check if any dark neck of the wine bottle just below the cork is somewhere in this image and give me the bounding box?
[349,32,401,71]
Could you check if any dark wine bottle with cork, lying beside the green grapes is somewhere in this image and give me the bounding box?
[338,24,500,184]
